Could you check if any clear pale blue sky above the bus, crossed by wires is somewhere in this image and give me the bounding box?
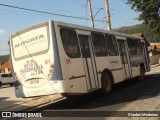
[0,0,141,55]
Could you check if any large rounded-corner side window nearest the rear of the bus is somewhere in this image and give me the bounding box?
[60,28,81,58]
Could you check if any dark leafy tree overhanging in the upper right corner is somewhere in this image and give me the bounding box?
[128,0,160,37]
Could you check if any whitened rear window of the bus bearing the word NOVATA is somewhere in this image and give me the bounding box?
[11,25,49,60]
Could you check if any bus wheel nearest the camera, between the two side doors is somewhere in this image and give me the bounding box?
[101,72,113,95]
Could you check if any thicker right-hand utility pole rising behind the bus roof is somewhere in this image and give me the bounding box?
[105,0,111,31]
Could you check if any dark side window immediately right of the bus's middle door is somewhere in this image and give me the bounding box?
[127,38,137,55]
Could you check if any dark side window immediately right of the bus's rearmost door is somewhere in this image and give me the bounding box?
[92,33,108,57]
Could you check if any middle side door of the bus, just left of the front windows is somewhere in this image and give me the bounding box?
[118,39,131,79]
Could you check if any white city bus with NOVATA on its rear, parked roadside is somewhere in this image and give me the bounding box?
[9,21,150,97]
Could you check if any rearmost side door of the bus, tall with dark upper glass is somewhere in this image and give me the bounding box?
[78,35,98,91]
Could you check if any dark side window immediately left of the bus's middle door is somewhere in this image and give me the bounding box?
[105,35,119,56]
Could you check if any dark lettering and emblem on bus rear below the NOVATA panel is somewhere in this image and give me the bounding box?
[20,60,43,76]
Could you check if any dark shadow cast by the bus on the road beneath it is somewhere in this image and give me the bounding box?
[33,71,160,111]
